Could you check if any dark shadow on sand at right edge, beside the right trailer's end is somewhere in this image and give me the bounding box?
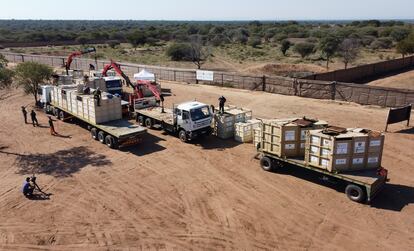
[371,183,414,212]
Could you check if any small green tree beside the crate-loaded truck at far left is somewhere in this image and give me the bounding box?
[15,62,53,104]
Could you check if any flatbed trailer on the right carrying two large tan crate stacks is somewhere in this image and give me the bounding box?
[258,149,388,203]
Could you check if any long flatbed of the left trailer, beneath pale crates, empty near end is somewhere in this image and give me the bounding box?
[47,102,147,149]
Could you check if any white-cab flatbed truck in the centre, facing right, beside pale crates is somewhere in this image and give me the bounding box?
[135,101,213,142]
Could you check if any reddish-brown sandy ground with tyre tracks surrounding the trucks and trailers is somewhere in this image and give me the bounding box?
[0,83,414,250]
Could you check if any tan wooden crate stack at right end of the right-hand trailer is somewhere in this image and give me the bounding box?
[305,128,384,172]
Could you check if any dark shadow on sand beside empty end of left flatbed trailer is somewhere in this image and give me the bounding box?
[121,133,166,156]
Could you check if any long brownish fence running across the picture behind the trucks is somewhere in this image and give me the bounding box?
[3,52,414,107]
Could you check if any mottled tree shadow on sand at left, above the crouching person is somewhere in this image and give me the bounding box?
[14,146,112,177]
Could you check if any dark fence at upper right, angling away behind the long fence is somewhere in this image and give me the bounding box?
[303,56,414,83]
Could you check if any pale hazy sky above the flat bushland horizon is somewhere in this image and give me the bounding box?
[0,0,414,21]
